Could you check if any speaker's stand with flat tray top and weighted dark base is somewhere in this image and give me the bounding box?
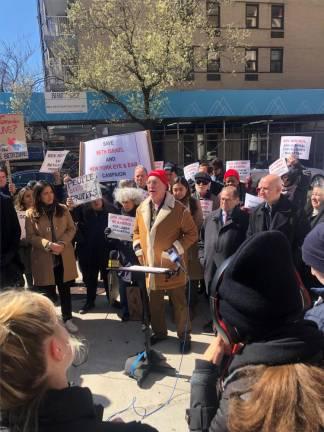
[107,266,176,387]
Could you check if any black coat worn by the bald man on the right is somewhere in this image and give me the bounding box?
[247,195,310,267]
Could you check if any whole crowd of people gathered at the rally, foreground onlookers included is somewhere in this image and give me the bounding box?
[0,156,324,432]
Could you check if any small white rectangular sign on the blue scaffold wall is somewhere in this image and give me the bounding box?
[45,92,88,114]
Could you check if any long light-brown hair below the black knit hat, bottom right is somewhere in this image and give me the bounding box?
[228,363,324,432]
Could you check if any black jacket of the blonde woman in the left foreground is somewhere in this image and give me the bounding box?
[39,387,157,432]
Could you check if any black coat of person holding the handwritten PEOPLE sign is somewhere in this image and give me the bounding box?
[72,201,118,268]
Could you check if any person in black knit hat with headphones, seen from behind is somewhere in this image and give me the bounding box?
[187,231,324,432]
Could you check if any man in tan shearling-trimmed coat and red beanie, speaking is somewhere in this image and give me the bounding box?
[133,170,198,352]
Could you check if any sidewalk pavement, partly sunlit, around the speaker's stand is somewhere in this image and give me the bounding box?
[64,287,212,432]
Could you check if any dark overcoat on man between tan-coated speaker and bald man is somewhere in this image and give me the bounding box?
[198,207,249,292]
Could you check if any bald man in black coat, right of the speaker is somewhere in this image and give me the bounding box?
[247,175,310,262]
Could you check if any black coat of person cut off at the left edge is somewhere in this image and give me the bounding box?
[0,192,23,288]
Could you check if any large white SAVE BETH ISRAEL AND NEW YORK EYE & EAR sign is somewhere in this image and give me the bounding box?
[81,131,152,182]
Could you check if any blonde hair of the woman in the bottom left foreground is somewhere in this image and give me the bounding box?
[0,291,62,431]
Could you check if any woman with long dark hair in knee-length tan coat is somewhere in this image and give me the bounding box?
[26,181,78,333]
